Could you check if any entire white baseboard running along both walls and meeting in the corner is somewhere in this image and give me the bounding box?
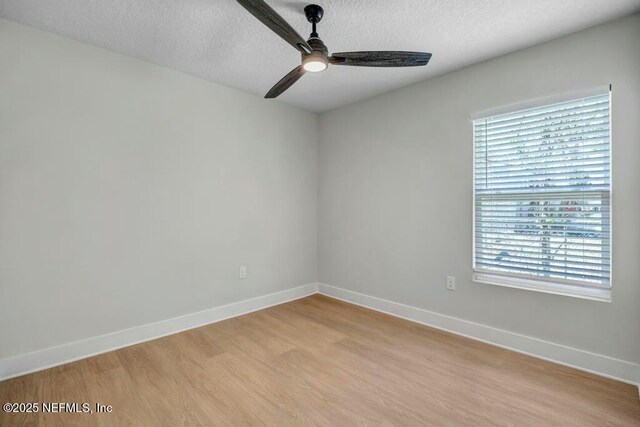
[0,283,640,392]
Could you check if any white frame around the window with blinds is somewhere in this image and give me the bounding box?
[469,85,614,302]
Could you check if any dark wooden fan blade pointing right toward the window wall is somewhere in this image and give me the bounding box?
[329,51,431,67]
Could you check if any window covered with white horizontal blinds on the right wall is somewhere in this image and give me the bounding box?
[473,88,611,300]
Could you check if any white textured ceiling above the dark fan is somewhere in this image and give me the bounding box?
[0,0,640,112]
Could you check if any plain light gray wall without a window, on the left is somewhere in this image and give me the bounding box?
[0,20,317,358]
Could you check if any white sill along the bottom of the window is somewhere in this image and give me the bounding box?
[473,272,611,302]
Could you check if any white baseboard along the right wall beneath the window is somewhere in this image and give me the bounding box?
[318,283,640,386]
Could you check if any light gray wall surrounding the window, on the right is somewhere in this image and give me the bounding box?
[318,15,640,363]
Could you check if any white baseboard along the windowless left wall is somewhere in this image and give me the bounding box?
[0,283,318,381]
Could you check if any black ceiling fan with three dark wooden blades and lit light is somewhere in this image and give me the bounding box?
[238,0,431,98]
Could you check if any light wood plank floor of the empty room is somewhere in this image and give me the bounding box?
[0,295,640,426]
